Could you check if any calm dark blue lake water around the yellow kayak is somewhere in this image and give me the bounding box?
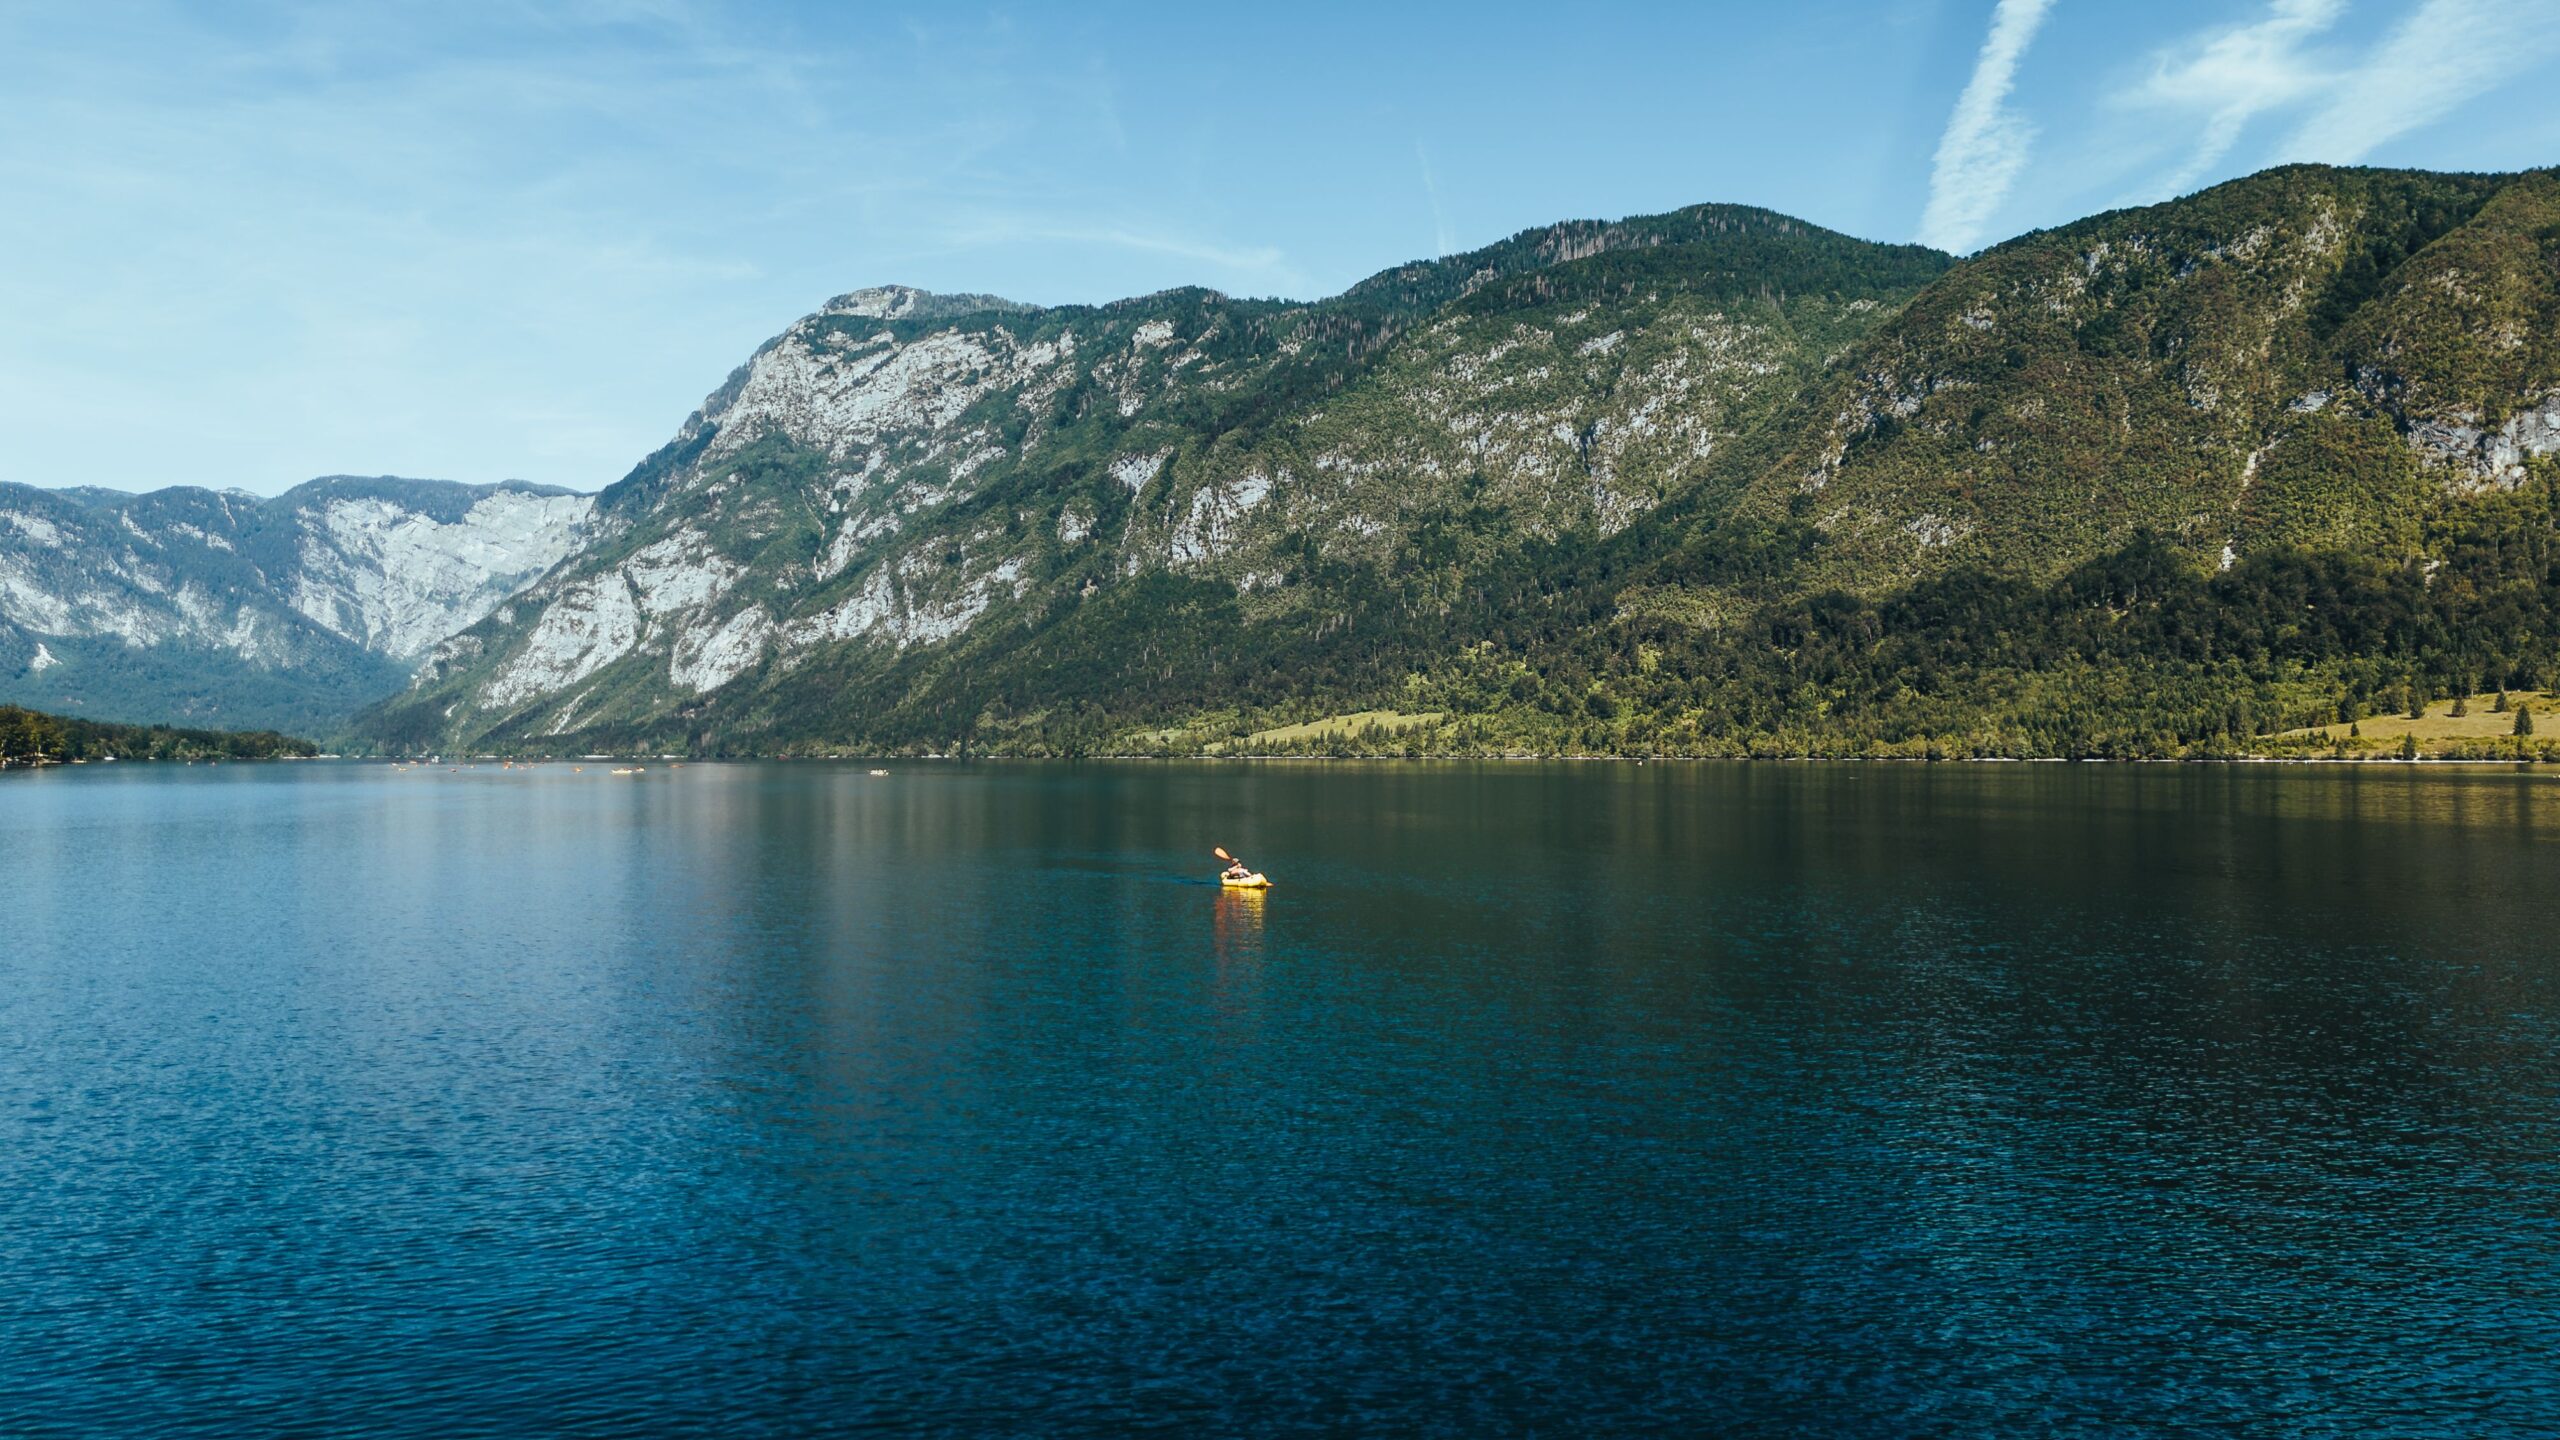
[0,764,2560,1437]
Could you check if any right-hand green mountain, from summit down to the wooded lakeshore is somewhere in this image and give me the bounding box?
[1536,167,2560,756]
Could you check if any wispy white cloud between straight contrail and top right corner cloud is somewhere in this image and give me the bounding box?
[2120,0,2345,200]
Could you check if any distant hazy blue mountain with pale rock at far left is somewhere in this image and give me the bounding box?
[0,477,594,733]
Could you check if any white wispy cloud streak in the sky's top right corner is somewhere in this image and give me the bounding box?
[2284,0,2560,164]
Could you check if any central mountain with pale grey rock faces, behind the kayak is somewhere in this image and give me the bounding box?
[364,205,1951,748]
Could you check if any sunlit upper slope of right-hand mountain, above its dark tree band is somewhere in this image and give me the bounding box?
[1699,167,2560,594]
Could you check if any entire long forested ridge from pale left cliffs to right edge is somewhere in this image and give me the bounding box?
[335,167,2560,753]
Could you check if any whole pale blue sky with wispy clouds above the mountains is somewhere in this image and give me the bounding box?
[0,0,2560,492]
